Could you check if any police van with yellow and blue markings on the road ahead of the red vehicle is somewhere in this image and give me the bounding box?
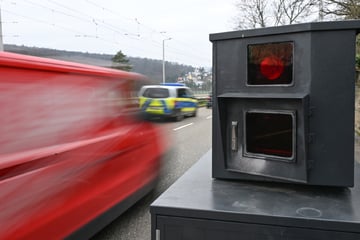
[139,83,198,121]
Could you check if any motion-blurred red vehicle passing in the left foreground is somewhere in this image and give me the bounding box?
[0,52,165,239]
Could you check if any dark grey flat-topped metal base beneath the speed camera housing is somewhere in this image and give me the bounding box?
[150,151,360,240]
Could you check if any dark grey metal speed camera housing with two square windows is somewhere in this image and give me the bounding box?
[210,21,360,187]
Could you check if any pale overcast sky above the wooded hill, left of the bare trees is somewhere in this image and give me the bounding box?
[0,0,237,67]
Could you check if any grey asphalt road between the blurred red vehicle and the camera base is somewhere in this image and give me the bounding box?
[92,108,212,240]
